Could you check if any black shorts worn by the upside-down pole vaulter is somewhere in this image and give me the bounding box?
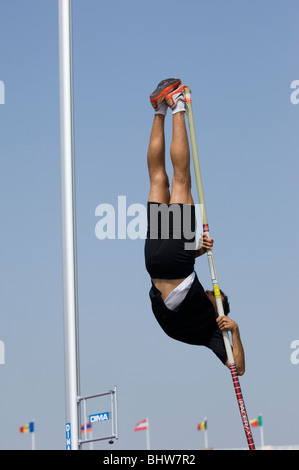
[144,202,196,279]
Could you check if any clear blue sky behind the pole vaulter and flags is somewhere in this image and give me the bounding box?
[0,0,299,450]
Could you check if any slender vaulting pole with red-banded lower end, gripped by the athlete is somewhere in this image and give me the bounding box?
[185,87,255,450]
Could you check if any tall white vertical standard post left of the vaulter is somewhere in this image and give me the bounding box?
[58,0,79,450]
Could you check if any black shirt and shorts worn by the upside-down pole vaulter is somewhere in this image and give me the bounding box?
[145,202,227,364]
